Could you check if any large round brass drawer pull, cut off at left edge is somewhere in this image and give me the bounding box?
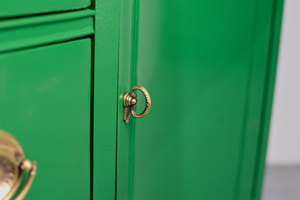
[0,130,37,200]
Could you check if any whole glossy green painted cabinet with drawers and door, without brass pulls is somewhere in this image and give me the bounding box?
[0,0,283,200]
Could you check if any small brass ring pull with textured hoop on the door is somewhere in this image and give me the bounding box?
[123,85,151,123]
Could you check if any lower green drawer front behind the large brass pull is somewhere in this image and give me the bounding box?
[0,39,91,200]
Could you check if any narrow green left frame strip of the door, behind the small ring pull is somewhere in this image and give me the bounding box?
[116,0,137,200]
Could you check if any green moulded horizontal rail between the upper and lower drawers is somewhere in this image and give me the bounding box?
[0,10,95,52]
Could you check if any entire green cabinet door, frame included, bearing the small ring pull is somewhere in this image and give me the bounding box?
[117,0,278,200]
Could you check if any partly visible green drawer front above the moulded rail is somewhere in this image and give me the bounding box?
[0,0,91,18]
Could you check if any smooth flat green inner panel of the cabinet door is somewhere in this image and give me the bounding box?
[133,0,256,200]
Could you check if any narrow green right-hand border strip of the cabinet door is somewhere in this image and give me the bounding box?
[237,0,283,200]
